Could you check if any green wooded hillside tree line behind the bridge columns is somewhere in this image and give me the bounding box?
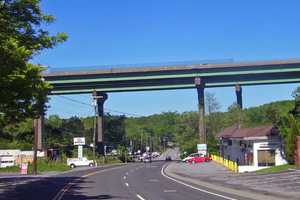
[0,93,300,162]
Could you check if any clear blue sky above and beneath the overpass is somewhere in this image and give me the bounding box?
[34,0,300,117]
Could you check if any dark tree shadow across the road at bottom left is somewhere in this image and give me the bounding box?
[0,175,126,200]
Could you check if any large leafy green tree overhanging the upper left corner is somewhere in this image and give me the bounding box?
[0,0,67,126]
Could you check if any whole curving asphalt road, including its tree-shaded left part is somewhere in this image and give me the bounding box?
[0,162,244,200]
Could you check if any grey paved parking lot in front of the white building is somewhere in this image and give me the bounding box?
[168,162,300,199]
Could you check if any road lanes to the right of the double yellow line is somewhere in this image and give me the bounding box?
[56,162,241,200]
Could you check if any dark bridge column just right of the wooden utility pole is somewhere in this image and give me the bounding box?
[96,92,108,155]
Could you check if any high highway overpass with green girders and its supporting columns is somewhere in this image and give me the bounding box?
[38,60,300,152]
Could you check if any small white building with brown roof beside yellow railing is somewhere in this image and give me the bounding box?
[218,126,287,172]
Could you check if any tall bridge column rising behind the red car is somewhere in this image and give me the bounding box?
[195,78,206,144]
